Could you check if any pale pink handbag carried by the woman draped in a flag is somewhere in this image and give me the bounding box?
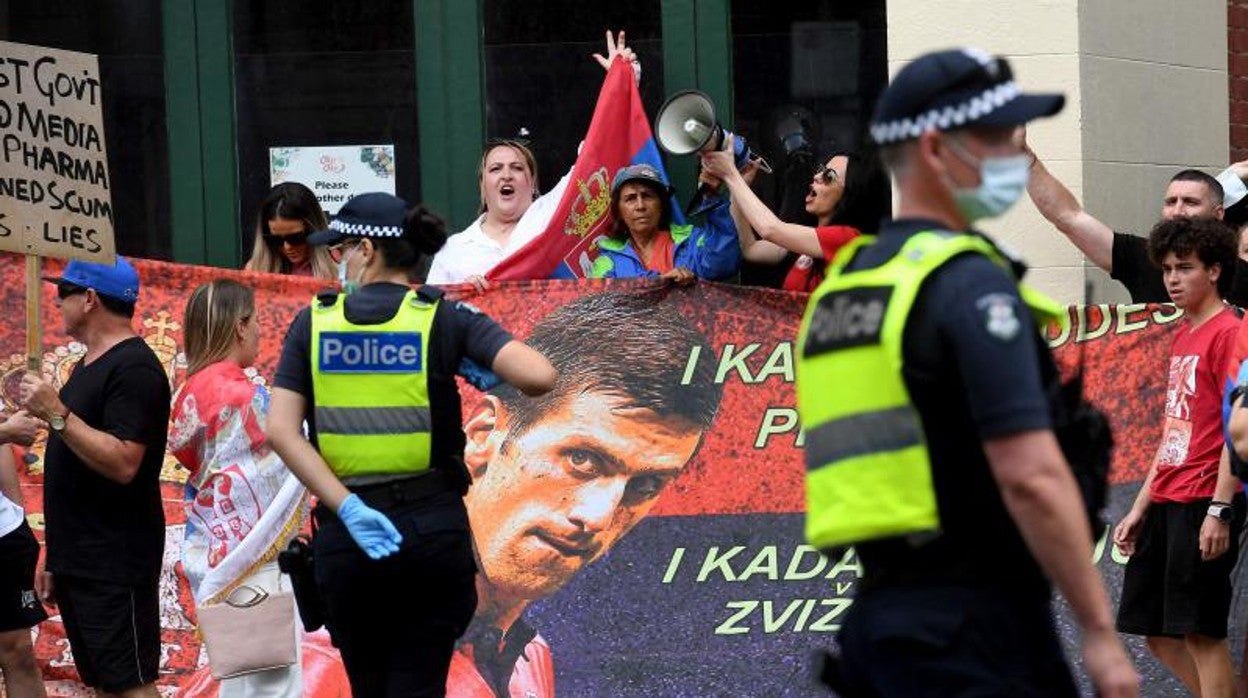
[196,584,298,679]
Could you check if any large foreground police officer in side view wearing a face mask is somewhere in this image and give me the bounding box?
[797,49,1138,696]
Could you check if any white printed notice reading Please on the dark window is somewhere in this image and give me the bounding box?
[268,145,394,216]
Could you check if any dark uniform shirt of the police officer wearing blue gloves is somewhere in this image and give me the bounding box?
[273,282,512,467]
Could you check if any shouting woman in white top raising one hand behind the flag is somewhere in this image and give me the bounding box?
[426,31,641,291]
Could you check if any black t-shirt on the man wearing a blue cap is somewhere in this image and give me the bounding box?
[44,337,170,586]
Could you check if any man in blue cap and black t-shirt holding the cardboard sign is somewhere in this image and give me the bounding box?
[21,257,170,697]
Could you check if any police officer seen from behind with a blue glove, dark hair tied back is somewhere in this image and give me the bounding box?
[267,194,557,697]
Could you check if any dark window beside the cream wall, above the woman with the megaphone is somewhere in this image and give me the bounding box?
[733,0,889,286]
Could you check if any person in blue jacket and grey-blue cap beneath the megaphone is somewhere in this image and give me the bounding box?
[590,164,741,283]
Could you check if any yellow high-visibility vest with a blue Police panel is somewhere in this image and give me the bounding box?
[312,291,437,477]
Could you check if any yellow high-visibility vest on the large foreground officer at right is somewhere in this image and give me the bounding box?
[796,231,1065,548]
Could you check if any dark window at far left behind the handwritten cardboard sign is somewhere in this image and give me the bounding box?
[0,0,172,260]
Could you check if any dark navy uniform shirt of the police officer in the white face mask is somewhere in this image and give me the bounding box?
[849,220,1052,601]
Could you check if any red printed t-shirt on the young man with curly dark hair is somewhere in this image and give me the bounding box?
[1149,307,1239,502]
